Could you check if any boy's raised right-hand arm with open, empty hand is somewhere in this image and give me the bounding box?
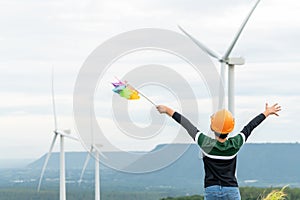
[241,103,281,140]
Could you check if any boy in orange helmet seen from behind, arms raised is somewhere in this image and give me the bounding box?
[157,103,281,200]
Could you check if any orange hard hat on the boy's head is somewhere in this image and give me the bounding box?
[210,109,234,134]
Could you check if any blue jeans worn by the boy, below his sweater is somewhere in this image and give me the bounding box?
[204,185,241,200]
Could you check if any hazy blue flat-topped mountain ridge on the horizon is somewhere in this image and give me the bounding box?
[27,143,300,186]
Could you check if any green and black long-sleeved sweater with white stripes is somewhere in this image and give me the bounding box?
[172,112,266,188]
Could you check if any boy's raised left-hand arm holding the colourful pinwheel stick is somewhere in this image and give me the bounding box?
[156,105,198,140]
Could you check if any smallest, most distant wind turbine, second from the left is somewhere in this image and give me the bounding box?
[78,103,106,200]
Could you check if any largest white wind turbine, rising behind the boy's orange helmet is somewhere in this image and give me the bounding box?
[178,0,260,115]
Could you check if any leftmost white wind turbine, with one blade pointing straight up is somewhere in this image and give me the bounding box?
[37,69,78,200]
